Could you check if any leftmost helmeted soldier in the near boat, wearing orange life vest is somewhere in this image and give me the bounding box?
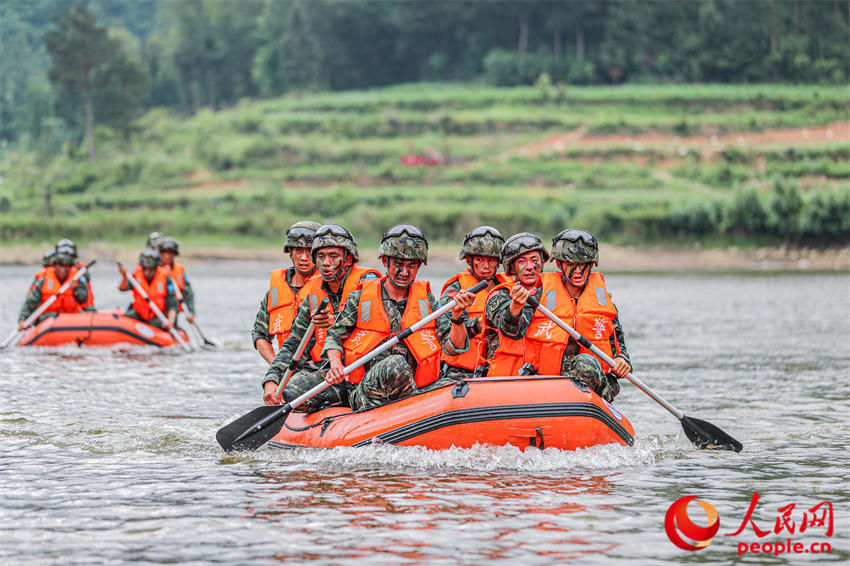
[251,220,320,364]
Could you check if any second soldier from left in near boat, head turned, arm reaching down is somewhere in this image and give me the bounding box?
[263,224,381,411]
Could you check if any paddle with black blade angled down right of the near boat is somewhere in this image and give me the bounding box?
[528,297,744,452]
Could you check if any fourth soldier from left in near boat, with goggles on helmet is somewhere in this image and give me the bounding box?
[440,226,508,379]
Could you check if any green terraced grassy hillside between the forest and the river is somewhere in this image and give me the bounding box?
[0,84,850,252]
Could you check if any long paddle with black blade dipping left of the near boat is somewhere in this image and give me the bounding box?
[215,279,489,452]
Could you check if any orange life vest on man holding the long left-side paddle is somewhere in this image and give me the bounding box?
[342,277,443,387]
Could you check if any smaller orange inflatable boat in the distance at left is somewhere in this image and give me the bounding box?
[18,310,185,347]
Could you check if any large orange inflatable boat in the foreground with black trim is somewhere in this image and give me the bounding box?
[270,375,634,450]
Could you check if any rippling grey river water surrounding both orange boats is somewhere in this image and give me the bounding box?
[0,263,850,565]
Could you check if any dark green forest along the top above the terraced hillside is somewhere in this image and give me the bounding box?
[0,0,850,150]
